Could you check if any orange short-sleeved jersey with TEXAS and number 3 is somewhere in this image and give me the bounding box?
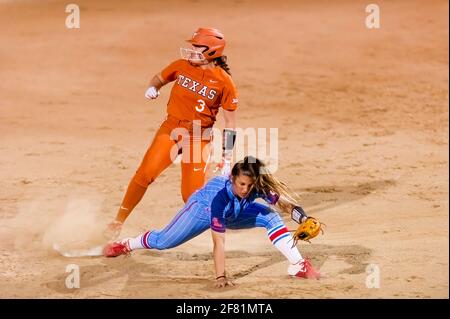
[161,59,238,127]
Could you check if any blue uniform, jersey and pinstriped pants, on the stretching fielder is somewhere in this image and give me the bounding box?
[142,176,289,250]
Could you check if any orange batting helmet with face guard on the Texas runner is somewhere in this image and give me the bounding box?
[187,28,225,60]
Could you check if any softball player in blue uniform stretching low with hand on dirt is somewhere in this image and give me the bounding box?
[104,157,320,287]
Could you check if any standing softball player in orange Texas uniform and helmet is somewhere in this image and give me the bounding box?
[106,28,238,238]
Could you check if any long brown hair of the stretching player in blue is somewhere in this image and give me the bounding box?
[231,156,299,214]
